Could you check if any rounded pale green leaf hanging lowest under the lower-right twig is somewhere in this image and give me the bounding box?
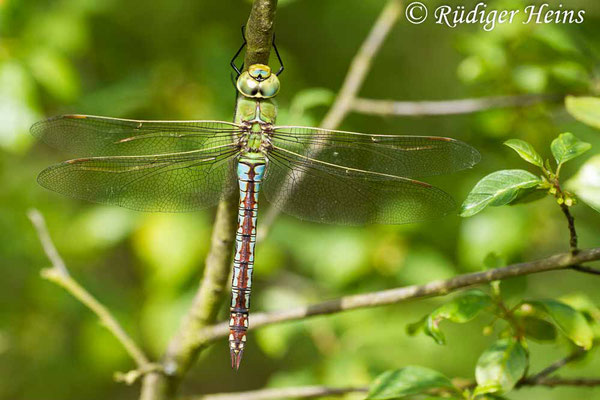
[474,338,528,395]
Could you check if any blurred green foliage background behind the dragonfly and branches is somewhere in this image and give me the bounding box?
[0,0,600,400]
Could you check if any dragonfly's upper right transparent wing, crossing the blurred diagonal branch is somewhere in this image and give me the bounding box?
[271,126,481,178]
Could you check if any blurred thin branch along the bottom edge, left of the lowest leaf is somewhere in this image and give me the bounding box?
[184,386,369,400]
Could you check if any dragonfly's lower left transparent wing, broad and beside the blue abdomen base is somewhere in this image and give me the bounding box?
[38,145,238,212]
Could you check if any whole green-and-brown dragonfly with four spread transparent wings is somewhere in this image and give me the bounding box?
[31,39,480,369]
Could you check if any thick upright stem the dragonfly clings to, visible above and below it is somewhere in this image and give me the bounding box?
[140,0,277,400]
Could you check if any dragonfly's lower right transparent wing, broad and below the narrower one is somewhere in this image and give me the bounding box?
[264,147,454,225]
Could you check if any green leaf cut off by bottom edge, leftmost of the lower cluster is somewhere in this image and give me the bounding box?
[367,366,455,400]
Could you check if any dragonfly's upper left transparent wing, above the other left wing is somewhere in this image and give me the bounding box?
[31,115,240,156]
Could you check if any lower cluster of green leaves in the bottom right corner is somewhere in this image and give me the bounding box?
[367,283,600,400]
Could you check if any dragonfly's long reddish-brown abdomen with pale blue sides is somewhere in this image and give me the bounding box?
[229,158,265,368]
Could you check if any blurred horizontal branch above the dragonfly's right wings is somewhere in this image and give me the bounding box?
[352,94,564,117]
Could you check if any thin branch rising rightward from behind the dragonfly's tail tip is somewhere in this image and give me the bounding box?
[198,248,600,342]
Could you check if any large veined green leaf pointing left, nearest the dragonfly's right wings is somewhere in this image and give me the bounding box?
[460,169,542,217]
